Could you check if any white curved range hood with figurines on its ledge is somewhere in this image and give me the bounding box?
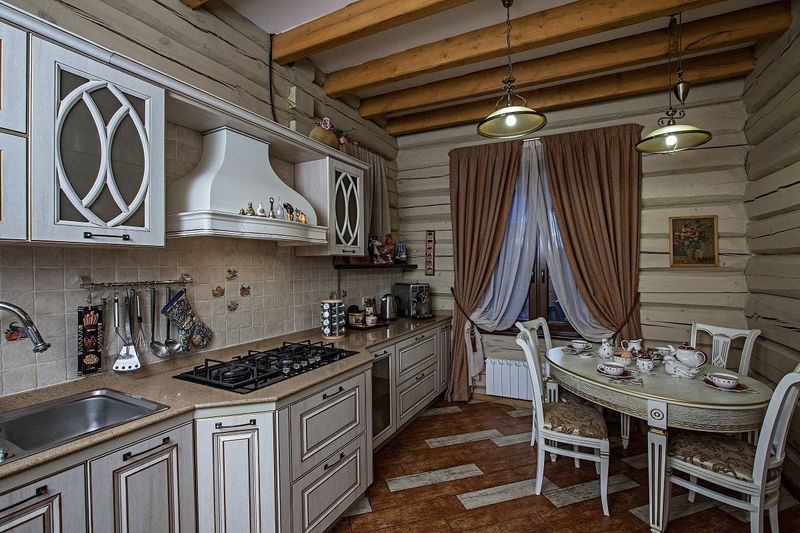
[167,127,327,245]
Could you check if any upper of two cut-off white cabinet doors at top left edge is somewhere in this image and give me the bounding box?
[0,22,28,133]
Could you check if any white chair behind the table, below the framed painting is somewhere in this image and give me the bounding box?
[619,322,761,450]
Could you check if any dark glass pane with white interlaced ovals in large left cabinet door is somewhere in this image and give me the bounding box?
[55,68,150,228]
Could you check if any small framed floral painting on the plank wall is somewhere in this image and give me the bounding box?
[669,215,719,268]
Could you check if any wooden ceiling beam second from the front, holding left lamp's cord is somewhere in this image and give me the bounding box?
[325,0,720,97]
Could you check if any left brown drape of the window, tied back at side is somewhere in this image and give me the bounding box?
[447,141,522,401]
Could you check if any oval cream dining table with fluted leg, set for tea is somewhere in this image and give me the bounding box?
[547,347,772,532]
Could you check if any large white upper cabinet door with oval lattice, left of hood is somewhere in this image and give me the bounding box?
[31,37,165,246]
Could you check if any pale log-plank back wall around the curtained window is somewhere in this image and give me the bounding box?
[397,80,749,342]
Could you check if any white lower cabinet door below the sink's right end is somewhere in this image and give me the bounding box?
[89,424,195,533]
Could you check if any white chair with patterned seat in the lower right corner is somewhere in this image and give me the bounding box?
[667,365,800,533]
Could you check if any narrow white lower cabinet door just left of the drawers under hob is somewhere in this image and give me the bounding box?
[195,413,275,533]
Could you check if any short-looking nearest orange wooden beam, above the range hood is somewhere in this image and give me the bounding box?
[276,0,472,65]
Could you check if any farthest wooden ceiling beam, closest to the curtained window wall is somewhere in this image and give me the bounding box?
[386,48,755,136]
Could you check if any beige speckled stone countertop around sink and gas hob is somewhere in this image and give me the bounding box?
[0,315,451,479]
